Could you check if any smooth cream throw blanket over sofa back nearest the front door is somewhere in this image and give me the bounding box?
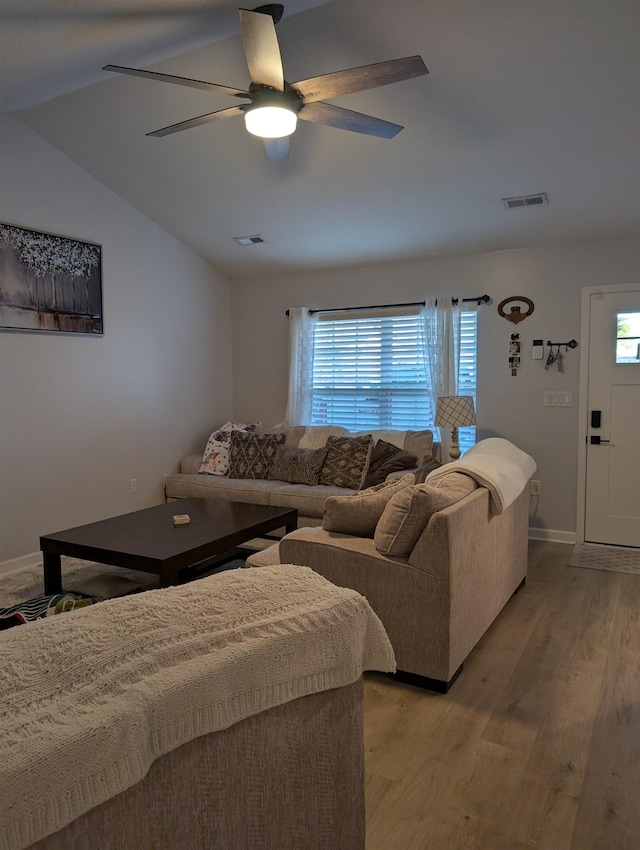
[425,437,536,514]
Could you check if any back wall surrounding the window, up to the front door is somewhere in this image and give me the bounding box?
[232,237,640,541]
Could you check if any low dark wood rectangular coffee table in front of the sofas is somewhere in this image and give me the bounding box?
[40,499,298,595]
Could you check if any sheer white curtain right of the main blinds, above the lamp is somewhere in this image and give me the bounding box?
[421,296,462,456]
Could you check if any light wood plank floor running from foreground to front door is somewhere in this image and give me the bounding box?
[365,542,640,850]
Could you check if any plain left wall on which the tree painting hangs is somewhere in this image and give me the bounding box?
[0,116,232,566]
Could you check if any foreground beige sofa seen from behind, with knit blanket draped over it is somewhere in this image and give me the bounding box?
[0,566,395,850]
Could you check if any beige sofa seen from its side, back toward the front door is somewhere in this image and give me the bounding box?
[247,439,535,692]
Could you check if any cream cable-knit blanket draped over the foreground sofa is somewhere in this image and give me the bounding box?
[0,564,395,850]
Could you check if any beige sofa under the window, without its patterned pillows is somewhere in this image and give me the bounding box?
[164,426,440,527]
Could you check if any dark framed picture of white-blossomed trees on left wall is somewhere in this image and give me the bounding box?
[0,222,102,334]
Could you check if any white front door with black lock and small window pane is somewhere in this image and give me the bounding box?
[584,285,640,547]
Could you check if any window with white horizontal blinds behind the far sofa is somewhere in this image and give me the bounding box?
[312,310,477,450]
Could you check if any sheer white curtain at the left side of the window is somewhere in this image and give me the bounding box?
[284,307,317,427]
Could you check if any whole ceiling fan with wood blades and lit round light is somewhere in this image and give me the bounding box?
[102,3,429,160]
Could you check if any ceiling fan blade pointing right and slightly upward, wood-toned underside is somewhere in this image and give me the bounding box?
[292,56,429,103]
